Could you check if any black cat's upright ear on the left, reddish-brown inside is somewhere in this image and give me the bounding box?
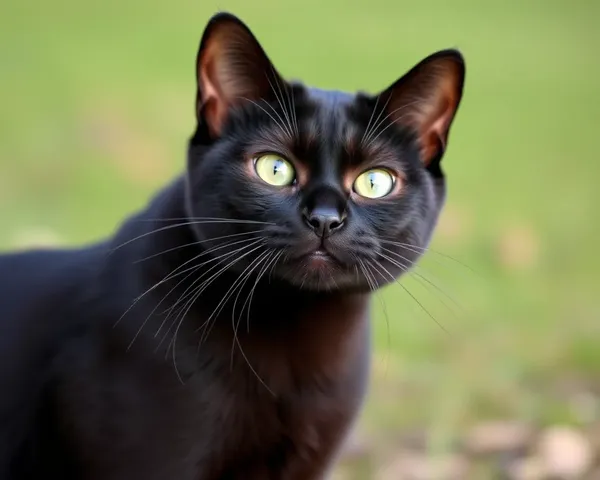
[196,13,285,137]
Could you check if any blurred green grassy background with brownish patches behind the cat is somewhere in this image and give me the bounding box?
[0,0,600,480]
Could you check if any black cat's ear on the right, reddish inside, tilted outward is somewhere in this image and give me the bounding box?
[379,50,465,166]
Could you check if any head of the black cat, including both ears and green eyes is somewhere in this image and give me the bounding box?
[187,14,464,290]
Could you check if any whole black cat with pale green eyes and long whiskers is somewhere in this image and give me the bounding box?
[0,13,465,480]
